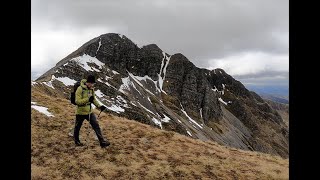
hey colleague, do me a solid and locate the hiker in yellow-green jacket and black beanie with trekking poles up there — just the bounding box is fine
[74,75,110,148]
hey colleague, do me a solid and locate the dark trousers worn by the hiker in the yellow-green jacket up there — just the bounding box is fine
[74,113,105,143]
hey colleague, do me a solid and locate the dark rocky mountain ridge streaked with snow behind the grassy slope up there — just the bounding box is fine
[32,33,289,158]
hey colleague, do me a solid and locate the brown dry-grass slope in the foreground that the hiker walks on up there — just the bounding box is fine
[31,85,289,180]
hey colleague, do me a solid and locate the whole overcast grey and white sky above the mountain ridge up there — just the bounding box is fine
[31,0,289,86]
